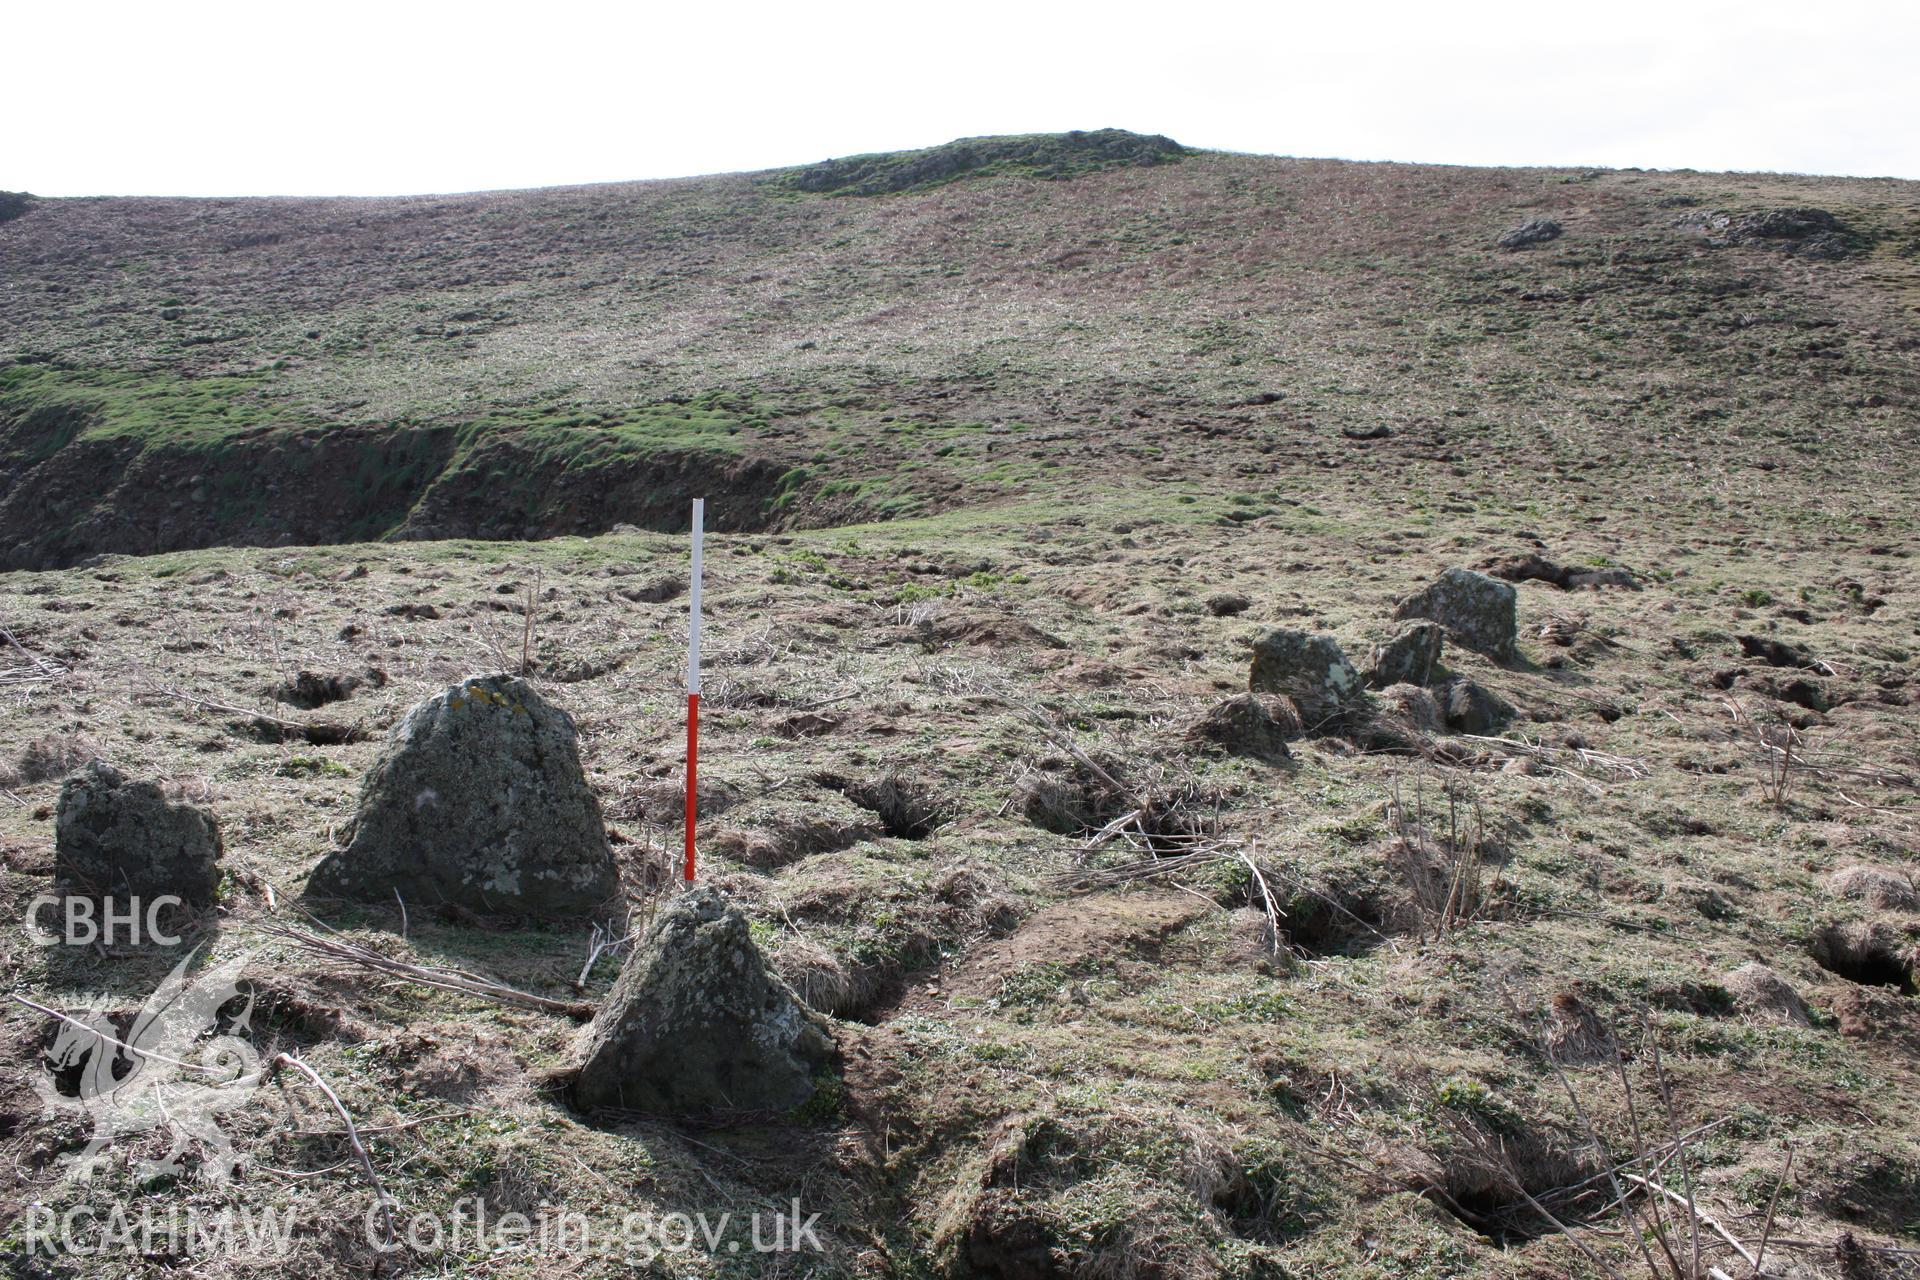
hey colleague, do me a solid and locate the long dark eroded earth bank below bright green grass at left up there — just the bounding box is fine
[0,416,851,568]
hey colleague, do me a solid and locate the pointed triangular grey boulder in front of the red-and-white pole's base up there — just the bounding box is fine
[572,887,837,1115]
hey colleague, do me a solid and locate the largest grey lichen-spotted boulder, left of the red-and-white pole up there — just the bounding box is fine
[311,676,620,921]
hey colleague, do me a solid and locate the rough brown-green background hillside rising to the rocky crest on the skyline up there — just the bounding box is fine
[0,134,1920,564]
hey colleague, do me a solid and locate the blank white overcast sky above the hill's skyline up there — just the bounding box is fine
[15,0,1920,196]
